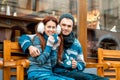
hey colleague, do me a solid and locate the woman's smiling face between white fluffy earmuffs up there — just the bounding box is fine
[45,21,57,36]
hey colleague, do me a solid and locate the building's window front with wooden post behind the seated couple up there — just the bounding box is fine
[0,0,120,79]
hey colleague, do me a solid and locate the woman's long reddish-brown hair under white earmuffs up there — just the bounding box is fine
[36,16,63,62]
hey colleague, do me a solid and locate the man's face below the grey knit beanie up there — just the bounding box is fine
[60,18,73,35]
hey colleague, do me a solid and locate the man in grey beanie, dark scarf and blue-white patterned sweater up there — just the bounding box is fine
[18,14,108,80]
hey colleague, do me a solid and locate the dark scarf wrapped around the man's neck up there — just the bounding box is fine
[63,32,75,49]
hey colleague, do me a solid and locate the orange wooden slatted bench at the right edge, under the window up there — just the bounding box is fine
[98,48,120,80]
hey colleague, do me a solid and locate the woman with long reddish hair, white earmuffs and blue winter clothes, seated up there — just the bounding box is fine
[19,16,73,80]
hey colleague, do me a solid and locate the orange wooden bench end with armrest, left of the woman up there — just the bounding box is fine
[1,40,30,80]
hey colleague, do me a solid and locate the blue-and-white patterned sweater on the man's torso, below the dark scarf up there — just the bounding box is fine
[54,38,85,73]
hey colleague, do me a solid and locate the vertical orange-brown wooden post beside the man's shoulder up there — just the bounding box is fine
[77,0,87,61]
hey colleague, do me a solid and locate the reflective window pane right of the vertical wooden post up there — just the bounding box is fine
[87,0,120,57]
